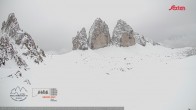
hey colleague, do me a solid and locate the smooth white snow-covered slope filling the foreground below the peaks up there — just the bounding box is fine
[0,43,196,110]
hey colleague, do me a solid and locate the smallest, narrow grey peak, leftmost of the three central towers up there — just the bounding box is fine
[72,28,88,50]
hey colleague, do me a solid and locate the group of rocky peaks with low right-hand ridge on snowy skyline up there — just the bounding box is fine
[72,18,158,50]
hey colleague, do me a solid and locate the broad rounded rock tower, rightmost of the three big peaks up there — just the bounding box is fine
[112,20,135,47]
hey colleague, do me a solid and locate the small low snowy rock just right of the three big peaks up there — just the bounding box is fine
[134,33,147,46]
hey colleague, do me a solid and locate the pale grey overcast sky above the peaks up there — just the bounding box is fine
[0,0,196,51]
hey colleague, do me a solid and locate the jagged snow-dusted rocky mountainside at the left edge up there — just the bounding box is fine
[0,13,46,85]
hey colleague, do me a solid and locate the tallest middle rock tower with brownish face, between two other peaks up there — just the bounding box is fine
[88,18,110,49]
